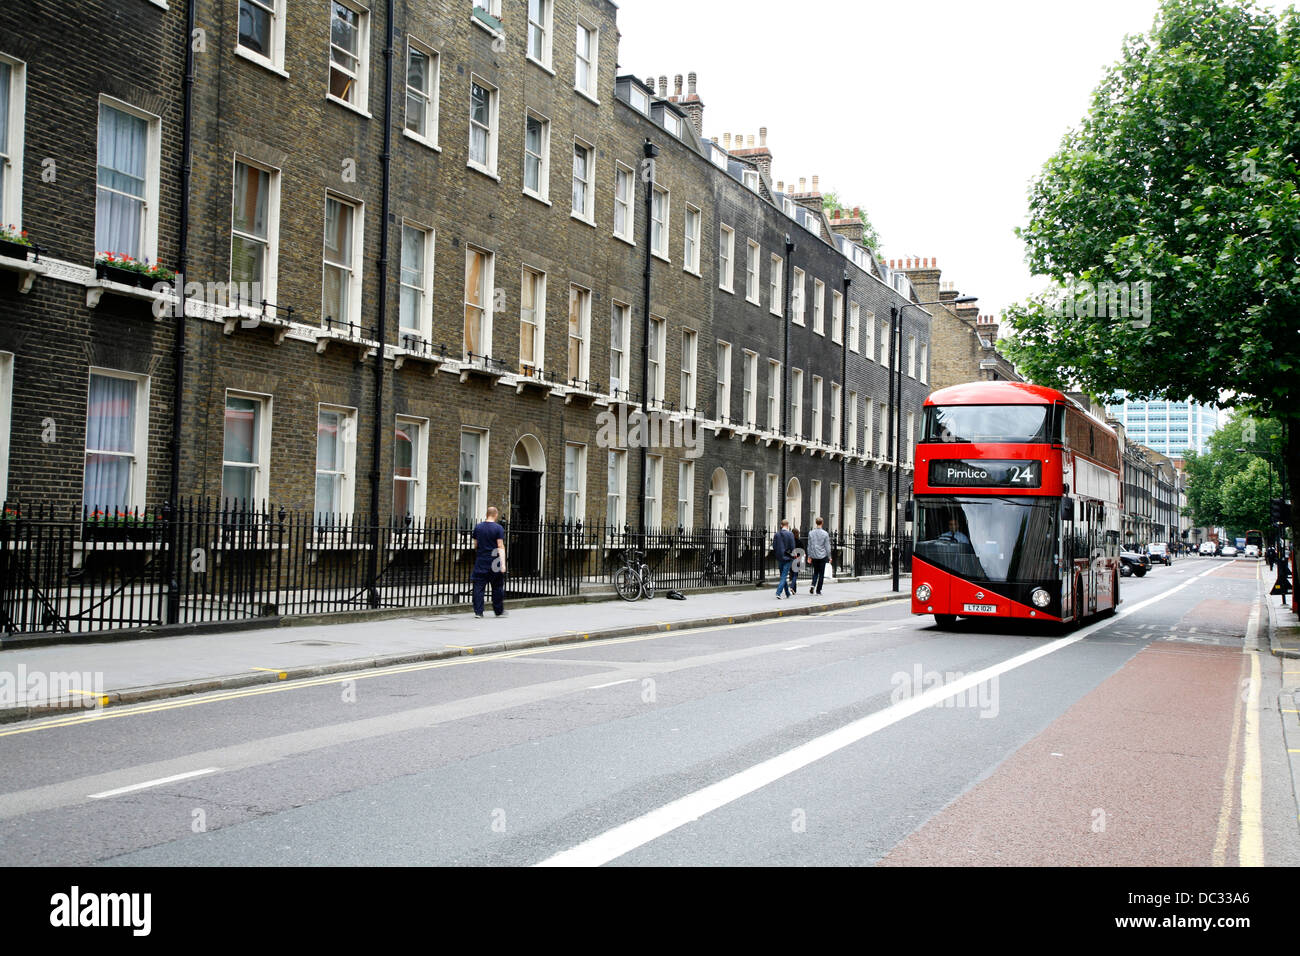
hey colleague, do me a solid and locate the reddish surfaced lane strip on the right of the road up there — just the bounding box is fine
[880,634,1249,866]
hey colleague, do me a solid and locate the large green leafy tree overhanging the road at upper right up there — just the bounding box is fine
[1005,0,1300,582]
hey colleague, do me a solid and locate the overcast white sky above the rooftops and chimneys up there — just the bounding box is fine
[618,0,1286,323]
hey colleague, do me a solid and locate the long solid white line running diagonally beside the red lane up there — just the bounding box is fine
[534,568,1214,866]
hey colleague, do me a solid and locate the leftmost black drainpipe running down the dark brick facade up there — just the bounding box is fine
[166,0,198,624]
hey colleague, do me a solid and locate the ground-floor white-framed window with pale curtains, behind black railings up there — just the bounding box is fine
[83,375,138,512]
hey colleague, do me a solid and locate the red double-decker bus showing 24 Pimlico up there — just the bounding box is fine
[911,382,1122,627]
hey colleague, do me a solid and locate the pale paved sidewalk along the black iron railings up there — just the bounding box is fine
[0,576,910,722]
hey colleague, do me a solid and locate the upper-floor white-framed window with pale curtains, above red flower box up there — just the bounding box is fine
[95,104,150,259]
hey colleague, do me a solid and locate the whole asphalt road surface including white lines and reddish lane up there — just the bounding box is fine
[0,558,1300,866]
